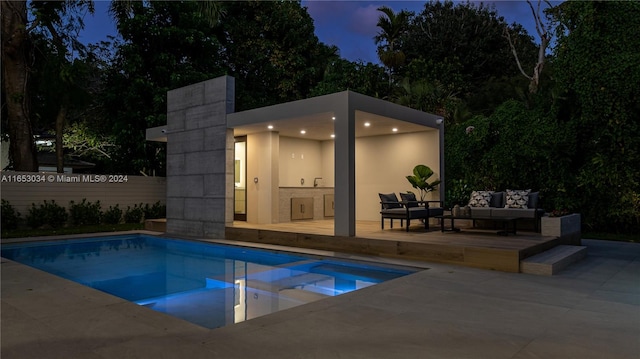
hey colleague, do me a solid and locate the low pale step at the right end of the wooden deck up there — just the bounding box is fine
[520,245,587,275]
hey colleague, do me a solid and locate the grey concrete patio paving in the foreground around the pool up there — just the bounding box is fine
[0,240,640,359]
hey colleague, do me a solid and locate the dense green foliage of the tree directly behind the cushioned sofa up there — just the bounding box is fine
[445,100,578,210]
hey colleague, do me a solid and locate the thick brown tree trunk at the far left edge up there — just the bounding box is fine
[0,0,38,172]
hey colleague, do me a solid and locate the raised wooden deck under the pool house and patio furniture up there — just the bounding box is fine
[226,220,562,272]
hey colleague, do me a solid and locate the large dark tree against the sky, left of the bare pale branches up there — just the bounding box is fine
[401,1,537,114]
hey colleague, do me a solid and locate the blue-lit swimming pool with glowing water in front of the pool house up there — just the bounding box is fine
[1,234,418,328]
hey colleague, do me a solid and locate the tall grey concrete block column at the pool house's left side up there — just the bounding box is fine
[167,76,235,238]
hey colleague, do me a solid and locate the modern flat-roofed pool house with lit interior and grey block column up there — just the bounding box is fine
[147,76,444,238]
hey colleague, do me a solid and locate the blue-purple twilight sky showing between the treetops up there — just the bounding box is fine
[81,0,537,63]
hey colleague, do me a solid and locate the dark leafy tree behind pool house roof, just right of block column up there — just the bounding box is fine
[219,1,337,111]
